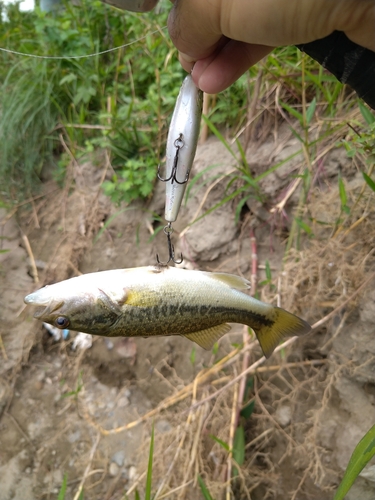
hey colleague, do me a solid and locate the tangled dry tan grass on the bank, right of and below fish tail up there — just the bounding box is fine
[78,174,375,500]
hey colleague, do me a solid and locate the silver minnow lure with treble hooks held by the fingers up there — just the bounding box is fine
[165,75,203,222]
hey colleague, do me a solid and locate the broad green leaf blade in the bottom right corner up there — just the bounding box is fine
[333,425,375,500]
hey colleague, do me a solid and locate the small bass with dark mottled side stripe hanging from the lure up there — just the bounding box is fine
[24,266,311,357]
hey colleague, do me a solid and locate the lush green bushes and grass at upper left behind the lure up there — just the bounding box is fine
[0,0,250,202]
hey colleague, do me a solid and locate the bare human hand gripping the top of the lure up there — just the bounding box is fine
[168,0,375,94]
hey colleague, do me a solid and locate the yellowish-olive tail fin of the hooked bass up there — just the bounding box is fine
[251,307,311,358]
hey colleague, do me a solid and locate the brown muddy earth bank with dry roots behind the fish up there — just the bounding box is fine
[0,127,375,500]
